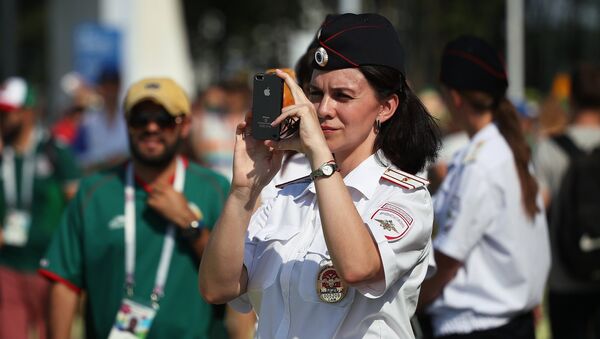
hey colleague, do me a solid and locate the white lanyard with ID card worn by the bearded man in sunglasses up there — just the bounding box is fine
[108,158,185,339]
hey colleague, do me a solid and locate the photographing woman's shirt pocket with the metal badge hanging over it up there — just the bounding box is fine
[298,237,355,308]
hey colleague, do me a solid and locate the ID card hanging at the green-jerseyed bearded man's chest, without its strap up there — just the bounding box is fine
[108,298,156,339]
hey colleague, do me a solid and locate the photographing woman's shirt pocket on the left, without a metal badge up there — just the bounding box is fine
[248,226,300,290]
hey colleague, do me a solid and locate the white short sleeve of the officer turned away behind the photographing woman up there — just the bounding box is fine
[434,166,503,262]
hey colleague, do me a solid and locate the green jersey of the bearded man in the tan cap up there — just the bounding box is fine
[40,163,229,339]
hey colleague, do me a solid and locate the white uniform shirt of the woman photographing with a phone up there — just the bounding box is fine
[231,156,433,339]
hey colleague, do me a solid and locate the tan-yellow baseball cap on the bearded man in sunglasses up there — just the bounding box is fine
[124,78,190,117]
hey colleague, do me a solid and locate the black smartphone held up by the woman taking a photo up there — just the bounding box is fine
[252,73,283,140]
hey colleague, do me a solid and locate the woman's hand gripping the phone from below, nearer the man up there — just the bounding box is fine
[231,112,283,196]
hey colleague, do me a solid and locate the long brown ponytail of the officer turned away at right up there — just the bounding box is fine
[460,91,540,218]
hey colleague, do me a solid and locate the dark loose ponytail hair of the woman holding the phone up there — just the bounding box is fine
[359,65,441,174]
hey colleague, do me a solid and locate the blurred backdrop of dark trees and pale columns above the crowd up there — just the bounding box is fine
[0,0,600,123]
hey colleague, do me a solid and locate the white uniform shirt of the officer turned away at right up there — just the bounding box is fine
[428,124,550,335]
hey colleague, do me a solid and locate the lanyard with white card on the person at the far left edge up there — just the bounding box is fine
[2,131,38,247]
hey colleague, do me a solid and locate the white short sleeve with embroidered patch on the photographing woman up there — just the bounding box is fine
[355,189,433,298]
